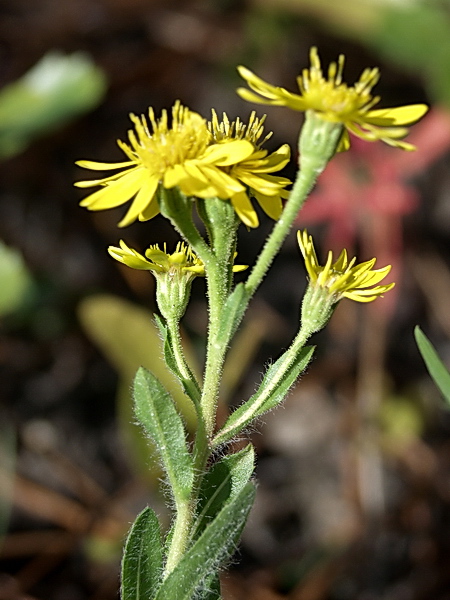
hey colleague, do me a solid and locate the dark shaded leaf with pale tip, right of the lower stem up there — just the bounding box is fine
[195,444,255,537]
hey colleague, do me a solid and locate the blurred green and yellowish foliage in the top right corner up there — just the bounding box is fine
[259,0,450,106]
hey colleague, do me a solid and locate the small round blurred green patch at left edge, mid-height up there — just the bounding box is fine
[0,242,32,316]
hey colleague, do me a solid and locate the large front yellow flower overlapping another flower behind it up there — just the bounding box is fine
[75,101,253,227]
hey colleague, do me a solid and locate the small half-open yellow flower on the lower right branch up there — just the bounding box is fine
[297,229,395,303]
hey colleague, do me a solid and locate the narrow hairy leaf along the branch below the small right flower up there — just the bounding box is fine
[212,346,315,447]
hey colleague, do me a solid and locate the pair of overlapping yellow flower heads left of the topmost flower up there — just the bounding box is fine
[75,101,290,227]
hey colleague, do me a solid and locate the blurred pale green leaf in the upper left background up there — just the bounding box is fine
[0,51,106,158]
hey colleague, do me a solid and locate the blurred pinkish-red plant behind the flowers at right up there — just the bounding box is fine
[297,109,450,312]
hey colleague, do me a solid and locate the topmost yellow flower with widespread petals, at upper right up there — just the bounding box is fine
[238,48,428,150]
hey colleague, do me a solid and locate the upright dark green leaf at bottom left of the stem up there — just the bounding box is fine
[121,507,163,600]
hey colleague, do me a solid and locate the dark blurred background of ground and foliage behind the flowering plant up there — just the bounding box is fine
[0,0,450,600]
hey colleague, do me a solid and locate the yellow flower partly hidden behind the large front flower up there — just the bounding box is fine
[208,110,291,227]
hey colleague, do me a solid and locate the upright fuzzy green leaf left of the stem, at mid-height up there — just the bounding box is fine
[134,367,194,498]
